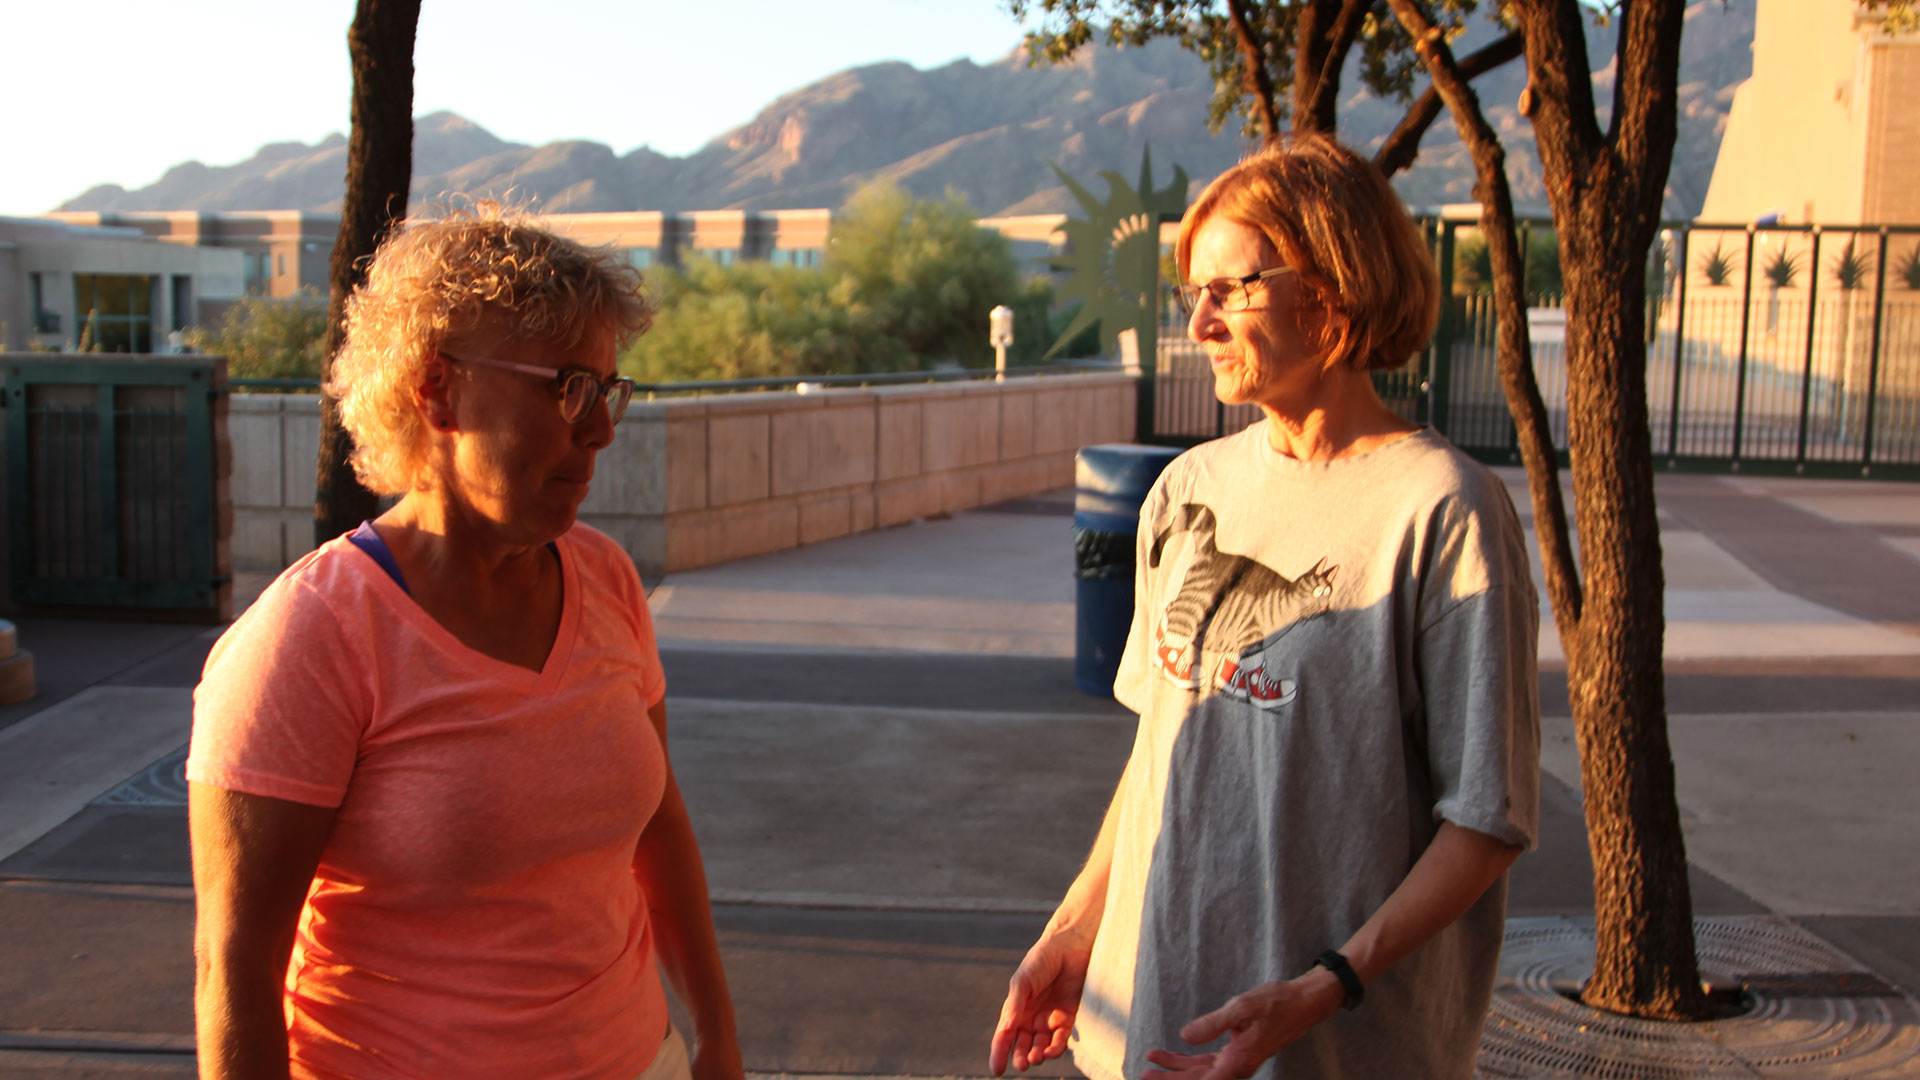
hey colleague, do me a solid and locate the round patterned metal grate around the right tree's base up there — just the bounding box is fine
[1476,917,1920,1080]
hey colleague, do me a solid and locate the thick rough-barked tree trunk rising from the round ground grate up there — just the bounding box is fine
[1515,0,1707,1020]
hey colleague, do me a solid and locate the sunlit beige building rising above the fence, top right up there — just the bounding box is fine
[1699,0,1920,225]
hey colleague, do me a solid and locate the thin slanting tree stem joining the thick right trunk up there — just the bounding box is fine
[1388,0,1584,634]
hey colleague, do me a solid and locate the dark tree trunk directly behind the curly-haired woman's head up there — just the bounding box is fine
[313,0,420,546]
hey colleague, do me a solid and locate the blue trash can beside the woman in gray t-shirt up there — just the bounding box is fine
[1073,442,1181,698]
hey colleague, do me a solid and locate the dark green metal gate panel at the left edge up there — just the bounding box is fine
[0,356,227,617]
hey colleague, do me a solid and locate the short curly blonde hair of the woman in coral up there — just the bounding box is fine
[323,202,653,496]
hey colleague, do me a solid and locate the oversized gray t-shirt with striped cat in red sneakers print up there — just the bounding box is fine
[1071,425,1540,1080]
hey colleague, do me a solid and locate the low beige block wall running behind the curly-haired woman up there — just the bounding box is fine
[240,375,1137,577]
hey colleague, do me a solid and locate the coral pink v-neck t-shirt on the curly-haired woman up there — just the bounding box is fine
[186,525,666,1080]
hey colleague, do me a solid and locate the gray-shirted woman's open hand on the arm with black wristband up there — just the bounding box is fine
[1140,969,1346,1080]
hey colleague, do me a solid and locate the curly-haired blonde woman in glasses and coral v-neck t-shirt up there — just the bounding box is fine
[186,206,741,1080]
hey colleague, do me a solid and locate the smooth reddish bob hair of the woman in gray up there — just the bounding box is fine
[1175,133,1440,371]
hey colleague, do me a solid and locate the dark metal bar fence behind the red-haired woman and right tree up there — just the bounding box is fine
[1142,221,1920,480]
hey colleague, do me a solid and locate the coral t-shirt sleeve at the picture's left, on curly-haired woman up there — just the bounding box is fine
[186,577,372,807]
